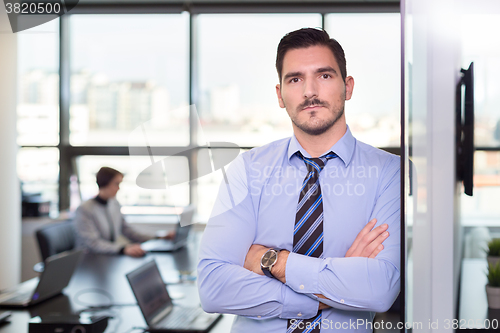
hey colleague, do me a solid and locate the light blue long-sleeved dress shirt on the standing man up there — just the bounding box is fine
[198,128,400,333]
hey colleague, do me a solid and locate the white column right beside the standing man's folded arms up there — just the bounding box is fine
[406,0,461,333]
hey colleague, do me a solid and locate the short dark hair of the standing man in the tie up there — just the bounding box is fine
[276,28,347,83]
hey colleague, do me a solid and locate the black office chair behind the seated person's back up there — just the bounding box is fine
[33,220,76,272]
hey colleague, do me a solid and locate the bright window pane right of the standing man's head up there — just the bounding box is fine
[325,14,401,147]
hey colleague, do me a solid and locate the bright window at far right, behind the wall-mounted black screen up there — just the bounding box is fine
[460,14,500,226]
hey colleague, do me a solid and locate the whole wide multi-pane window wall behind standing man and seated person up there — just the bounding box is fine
[18,5,400,220]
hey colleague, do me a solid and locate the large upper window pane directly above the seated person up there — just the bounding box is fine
[70,14,189,146]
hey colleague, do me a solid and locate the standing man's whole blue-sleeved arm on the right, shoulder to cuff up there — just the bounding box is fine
[285,160,400,312]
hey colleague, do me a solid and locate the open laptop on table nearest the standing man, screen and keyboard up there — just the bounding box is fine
[127,260,222,333]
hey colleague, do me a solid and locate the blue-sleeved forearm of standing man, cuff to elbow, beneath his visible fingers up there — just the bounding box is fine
[286,253,399,312]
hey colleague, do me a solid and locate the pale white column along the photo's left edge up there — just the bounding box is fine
[0,7,21,289]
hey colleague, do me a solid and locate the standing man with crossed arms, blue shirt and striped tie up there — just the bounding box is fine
[198,28,400,333]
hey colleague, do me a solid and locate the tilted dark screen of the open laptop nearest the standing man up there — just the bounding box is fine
[127,260,172,323]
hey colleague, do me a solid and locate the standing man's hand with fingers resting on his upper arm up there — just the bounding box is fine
[345,219,389,259]
